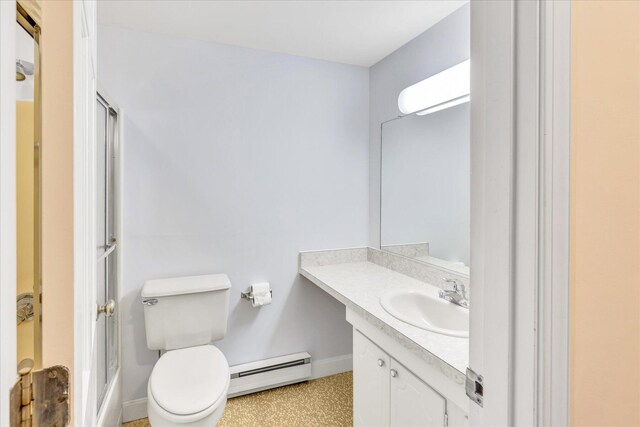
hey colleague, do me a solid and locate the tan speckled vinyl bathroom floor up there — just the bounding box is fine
[124,372,353,427]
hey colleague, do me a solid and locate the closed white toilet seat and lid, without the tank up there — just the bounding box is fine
[148,345,230,424]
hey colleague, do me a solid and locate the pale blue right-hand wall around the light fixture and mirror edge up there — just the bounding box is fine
[369,4,470,247]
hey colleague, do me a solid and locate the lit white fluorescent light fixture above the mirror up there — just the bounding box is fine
[398,59,471,114]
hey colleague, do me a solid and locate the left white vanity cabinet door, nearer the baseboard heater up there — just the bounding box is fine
[353,329,390,427]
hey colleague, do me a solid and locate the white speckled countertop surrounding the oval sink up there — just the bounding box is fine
[300,261,469,379]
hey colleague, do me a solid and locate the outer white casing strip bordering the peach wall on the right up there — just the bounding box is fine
[537,0,571,426]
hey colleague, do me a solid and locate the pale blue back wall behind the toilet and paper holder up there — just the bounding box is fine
[98,27,369,401]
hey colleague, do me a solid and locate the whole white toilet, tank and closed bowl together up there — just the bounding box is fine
[142,274,231,427]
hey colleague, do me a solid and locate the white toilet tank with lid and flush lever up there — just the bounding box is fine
[142,274,231,350]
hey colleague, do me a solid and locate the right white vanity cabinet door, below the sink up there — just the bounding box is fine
[390,359,446,427]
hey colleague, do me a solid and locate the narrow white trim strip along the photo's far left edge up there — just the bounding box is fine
[0,0,17,426]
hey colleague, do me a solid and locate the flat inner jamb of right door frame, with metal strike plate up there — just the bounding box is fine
[469,0,515,426]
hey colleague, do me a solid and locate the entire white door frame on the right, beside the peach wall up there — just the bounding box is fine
[469,0,571,426]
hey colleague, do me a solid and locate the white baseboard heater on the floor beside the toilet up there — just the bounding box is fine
[228,352,311,397]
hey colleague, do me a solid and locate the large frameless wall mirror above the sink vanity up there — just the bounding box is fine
[380,103,470,275]
